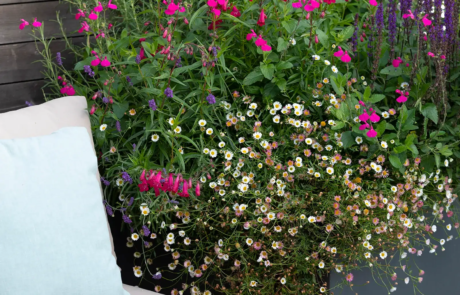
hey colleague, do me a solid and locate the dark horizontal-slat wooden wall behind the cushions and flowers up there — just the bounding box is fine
[0,0,83,112]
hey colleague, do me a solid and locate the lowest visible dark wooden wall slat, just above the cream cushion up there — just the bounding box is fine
[0,80,45,113]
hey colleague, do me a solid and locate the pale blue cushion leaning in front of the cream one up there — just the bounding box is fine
[0,127,129,295]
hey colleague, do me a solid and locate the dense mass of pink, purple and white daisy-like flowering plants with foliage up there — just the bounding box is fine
[20,0,460,295]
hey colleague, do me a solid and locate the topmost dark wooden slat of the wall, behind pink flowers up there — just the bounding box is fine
[0,1,80,44]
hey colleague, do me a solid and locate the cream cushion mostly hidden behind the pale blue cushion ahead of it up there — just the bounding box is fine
[0,96,161,295]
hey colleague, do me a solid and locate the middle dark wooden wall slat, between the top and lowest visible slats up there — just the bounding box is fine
[0,37,86,84]
